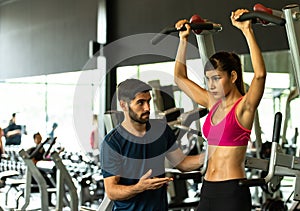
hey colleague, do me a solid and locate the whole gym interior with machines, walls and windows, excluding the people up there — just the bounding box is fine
[0,0,300,211]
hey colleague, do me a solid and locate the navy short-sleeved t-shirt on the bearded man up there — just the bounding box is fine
[100,120,178,211]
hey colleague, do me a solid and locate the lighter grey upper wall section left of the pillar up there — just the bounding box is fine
[0,0,97,79]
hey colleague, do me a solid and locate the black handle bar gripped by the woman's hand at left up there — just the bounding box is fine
[151,22,222,45]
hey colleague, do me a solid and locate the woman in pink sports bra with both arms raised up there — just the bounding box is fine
[174,9,266,211]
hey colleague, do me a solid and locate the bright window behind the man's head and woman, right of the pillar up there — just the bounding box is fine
[117,59,300,146]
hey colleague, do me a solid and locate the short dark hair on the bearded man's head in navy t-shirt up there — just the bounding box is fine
[118,79,152,102]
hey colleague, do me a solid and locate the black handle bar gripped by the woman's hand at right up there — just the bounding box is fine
[238,11,286,26]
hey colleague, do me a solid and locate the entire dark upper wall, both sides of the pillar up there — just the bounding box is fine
[0,0,299,79]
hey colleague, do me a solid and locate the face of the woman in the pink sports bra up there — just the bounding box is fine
[205,70,234,99]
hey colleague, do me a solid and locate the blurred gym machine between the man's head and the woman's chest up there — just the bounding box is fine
[148,80,208,155]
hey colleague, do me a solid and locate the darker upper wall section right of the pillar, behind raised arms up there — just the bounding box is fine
[108,0,299,65]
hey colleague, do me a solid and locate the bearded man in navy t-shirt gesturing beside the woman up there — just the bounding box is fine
[100,79,204,211]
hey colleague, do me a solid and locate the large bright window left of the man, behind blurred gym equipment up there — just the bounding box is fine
[0,72,104,151]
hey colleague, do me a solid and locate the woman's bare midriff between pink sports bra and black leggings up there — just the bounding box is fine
[204,146,247,181]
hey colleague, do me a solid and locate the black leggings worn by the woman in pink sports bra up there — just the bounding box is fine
[197,179,251,211]
